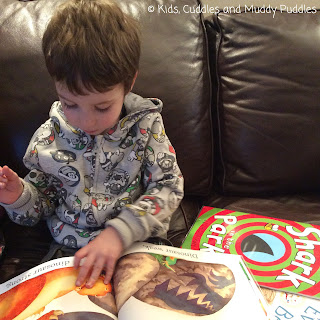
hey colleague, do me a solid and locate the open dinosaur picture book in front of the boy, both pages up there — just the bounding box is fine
[0,243,268,320]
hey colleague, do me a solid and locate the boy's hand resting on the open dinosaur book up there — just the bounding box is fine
[74,227,123,288]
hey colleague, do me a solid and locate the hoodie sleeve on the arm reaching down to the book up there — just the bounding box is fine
[106,113,183,247]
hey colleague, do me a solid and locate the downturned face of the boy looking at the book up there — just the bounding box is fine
[55,82,125,136]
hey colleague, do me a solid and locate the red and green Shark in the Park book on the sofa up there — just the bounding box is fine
[182,207,320,299]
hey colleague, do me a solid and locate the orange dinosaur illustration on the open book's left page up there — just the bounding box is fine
[0,267,112,320]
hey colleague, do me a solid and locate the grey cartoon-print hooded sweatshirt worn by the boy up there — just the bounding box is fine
[4,93,183,248]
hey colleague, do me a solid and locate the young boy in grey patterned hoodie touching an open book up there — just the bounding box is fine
[0,0,183,288]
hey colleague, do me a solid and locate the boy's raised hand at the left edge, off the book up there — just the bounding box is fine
[0,166,23,204]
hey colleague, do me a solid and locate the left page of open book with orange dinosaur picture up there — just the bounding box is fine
[0,257,117,320]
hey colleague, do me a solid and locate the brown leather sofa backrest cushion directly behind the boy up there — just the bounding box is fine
[0,0,213,195]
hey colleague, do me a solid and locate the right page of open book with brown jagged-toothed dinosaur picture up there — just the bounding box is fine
[114,243,268,320]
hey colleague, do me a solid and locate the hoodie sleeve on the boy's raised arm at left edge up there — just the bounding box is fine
[1,127,57,226]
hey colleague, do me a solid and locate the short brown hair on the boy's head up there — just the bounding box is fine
[42,0,140,95]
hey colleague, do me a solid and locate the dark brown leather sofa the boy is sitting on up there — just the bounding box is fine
[0,0,320,282]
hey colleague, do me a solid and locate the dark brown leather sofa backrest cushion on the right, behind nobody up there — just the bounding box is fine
[207,10,320,196]
